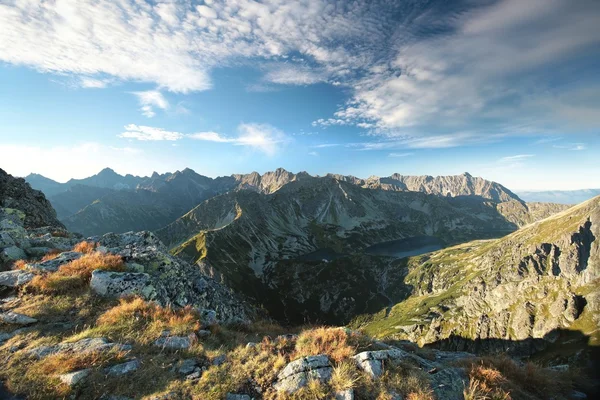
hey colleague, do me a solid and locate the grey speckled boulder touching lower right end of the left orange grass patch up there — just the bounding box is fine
[90,270,155,299]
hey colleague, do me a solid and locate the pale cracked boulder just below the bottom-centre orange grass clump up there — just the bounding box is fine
[273,354,333,393]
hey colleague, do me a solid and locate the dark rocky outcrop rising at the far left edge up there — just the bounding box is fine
[0,169,64,228]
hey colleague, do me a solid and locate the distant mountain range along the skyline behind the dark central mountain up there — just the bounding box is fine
[29,168,560,239]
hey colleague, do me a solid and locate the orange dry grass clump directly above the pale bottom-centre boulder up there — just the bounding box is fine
[294,327,359,362]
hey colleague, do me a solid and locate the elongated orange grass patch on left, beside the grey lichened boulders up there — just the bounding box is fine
[26,252,125,294]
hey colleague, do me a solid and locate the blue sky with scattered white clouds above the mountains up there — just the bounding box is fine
[0,0,600,190]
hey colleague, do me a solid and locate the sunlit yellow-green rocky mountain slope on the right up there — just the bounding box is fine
[357,197,600,352]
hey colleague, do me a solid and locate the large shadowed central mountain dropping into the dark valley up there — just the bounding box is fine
[156,176,565,323]
